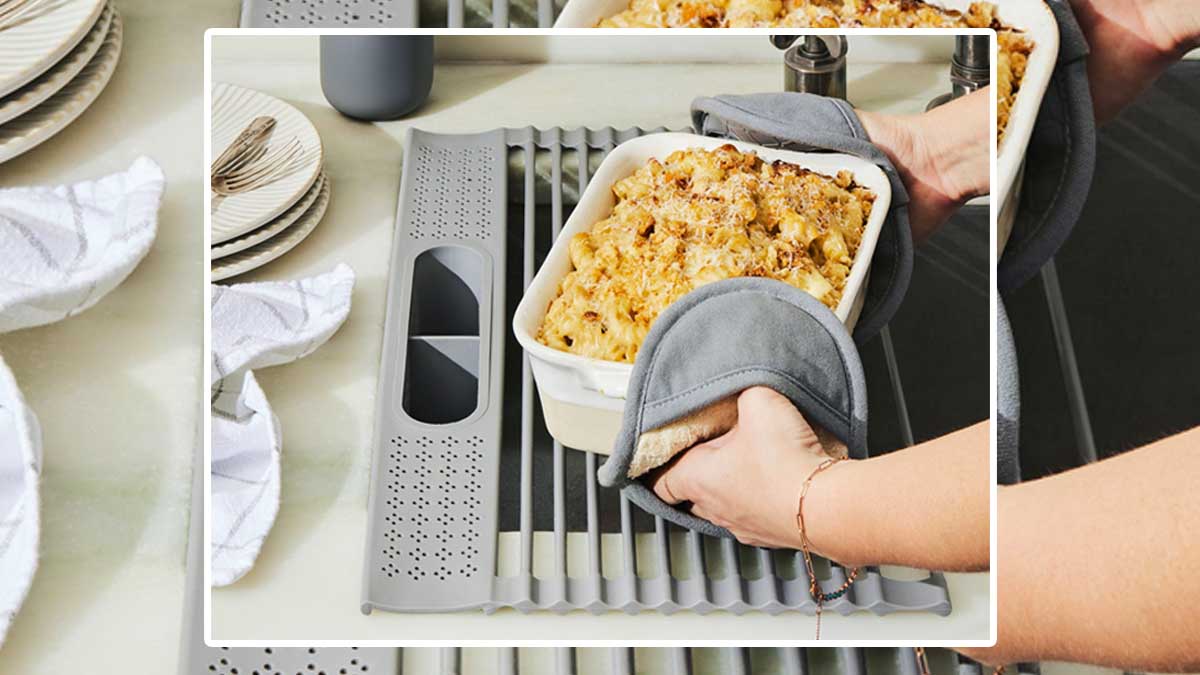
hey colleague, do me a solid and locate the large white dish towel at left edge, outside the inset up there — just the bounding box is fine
[0,157,166,645]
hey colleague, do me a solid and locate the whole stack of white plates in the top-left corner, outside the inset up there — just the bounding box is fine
[0,0,121,163]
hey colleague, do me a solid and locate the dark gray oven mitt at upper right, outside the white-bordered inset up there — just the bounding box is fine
[996,0,1096,293]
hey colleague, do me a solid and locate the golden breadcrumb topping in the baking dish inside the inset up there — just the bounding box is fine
[538,144,875,363]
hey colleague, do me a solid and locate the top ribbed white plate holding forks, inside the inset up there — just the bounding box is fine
[212,83,323,244]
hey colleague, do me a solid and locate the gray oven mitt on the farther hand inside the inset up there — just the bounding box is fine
[691,92,912,345]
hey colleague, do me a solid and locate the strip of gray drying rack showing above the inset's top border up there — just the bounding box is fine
[240,0,562,28]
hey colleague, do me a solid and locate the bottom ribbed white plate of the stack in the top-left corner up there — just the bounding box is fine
[0,12,124,162]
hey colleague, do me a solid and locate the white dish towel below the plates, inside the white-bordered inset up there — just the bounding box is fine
[209,264,354,586]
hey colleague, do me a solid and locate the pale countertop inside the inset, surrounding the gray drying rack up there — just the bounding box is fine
[212,37,989,640]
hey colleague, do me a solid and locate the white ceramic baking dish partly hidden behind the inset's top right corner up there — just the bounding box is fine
[554,0,1058,250]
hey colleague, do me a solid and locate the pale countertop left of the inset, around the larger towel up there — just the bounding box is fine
[0,0,236,675]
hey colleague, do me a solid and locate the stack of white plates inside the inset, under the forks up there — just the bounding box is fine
[211,83,329,281]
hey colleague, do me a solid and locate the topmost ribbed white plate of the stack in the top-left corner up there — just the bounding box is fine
[0,0,108,96]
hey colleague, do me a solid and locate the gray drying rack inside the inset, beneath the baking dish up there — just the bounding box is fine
[361,127,950,615]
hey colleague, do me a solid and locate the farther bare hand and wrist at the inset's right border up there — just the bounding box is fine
[857,86,991,244]
